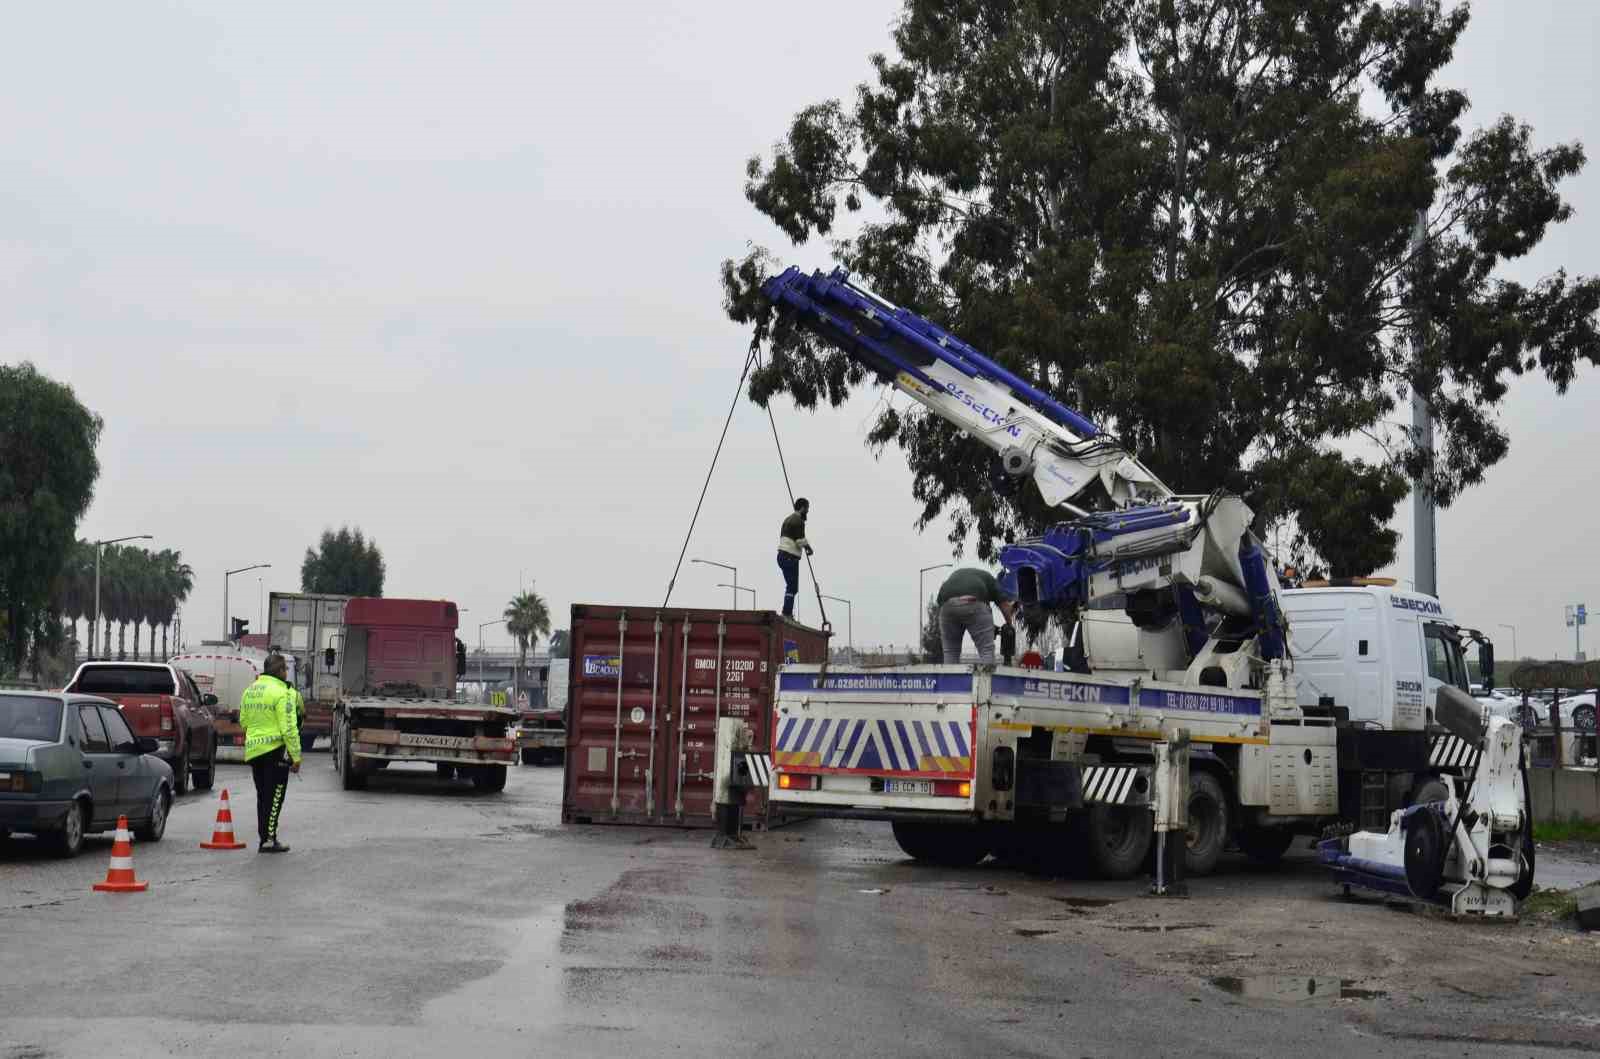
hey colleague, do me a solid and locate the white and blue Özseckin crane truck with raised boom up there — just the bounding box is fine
[763,269,1533,894]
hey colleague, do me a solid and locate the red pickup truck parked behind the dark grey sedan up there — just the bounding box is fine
[66,662,216,793]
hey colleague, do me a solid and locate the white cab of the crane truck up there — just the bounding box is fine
[1280,582,1469,731]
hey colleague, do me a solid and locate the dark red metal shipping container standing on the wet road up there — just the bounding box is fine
[562,605,827,827]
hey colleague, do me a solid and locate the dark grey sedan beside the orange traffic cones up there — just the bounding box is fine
[0,691,173,857]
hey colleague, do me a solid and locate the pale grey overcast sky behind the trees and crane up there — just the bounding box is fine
[12,0,1600,656]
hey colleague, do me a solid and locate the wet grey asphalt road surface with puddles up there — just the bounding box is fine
[0,753,1600,1059]
